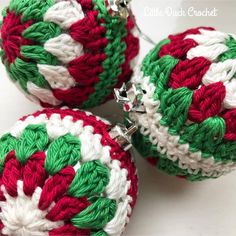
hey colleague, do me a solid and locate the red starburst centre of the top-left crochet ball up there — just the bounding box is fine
[1,10,33,64]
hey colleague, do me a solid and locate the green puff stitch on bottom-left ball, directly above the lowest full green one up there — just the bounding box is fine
[68,160,110,198]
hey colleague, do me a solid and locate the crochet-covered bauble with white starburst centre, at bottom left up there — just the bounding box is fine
[0,109,137,236]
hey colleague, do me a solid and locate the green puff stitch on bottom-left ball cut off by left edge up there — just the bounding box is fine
[0,133,17,173]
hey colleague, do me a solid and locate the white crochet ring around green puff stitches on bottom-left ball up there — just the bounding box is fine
[7,109,132,235]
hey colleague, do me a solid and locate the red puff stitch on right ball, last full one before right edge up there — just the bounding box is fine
[188,82,226,123]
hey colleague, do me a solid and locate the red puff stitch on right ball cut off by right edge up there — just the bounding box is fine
[221,109,236,141]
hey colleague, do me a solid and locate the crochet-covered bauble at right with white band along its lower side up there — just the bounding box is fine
[130,27,236,181]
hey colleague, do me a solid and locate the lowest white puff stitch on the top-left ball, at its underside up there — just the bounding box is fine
[27,81,62,106]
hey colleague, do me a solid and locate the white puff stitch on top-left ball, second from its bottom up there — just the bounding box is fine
[37,64,76,90]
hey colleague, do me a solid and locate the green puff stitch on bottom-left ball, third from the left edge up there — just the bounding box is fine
[44,134,81,175]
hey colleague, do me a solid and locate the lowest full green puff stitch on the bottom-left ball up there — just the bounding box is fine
[71,197,117,230]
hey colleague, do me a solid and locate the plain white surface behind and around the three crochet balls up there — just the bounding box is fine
[0,0,236,236]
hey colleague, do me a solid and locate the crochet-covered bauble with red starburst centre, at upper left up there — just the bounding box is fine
[0,0,139,108]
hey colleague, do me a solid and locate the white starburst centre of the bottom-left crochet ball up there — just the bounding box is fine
[0,180,64,236]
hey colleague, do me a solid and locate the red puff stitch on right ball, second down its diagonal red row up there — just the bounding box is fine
[169,57,211,90]
